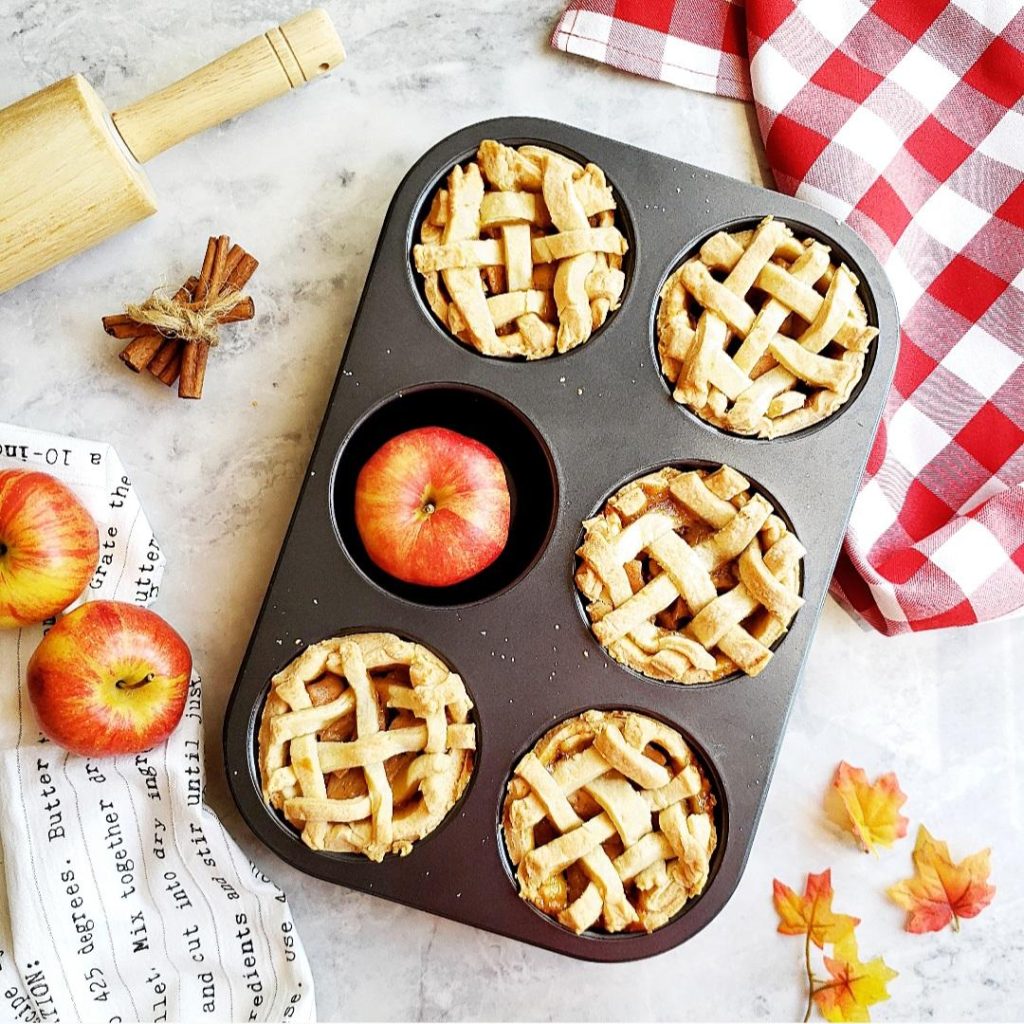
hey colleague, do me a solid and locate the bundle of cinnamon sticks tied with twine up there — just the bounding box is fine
[103,234,259,398]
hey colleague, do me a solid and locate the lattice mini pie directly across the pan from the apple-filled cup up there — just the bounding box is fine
[575,466,804,683]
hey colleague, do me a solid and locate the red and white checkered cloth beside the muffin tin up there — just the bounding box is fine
[552,0,1024,634]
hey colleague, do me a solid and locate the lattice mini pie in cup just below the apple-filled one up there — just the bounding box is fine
[259,633,476,861]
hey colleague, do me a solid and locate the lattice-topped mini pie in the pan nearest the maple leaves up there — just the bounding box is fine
[503,711,717,934]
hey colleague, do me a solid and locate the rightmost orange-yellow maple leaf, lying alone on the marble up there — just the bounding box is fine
[888,825,995,933]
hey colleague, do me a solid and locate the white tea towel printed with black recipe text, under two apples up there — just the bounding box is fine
[0,424,315,1022]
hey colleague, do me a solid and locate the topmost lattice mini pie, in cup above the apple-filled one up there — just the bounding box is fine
[413,139,627,359]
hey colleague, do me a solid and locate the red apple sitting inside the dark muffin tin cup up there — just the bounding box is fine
[355,427,511,587]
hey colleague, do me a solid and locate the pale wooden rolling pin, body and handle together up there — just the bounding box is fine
[0,10,345,292]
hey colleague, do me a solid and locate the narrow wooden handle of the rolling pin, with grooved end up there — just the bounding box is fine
[112,9,345,163]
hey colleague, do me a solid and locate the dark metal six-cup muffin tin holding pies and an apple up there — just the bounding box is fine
[224,118,898,962]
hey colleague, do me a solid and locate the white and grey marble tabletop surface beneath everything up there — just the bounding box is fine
[0,0,1024,1020]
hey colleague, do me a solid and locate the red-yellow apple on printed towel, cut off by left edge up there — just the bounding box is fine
[0,469,99,629]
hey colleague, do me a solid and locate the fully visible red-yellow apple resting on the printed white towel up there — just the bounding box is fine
[27,601,191,757]
